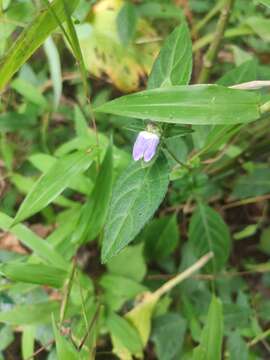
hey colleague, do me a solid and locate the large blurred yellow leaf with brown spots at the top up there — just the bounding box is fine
[76,0,160,92]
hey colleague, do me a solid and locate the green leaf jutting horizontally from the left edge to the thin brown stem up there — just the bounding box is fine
[0,263,68,288]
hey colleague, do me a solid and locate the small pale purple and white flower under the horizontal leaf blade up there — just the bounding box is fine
[132,131,159,162]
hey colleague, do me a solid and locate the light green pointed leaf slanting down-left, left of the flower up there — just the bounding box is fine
[14,151,93,224]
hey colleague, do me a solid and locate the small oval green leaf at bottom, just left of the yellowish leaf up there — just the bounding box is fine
[106,312,142,354]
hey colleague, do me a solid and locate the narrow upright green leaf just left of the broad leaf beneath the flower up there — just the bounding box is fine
[72,144,113,244]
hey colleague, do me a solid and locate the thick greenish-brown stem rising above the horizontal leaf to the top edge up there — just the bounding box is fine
[198,0,234,83]
